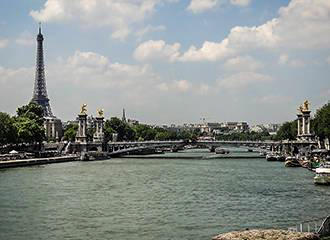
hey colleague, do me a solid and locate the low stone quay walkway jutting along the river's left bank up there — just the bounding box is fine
[0,154,80,169]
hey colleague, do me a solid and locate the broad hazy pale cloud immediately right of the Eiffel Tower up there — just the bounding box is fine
[56,51,157,88]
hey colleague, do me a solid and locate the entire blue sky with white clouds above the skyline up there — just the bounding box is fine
[0,0,330,123]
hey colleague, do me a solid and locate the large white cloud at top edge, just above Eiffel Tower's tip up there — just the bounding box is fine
[30,0,176,40]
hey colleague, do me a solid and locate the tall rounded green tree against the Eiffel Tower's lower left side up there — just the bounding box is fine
[14,103,45,143]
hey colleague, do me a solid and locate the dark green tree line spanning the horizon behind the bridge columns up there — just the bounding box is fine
[0,103,330,145]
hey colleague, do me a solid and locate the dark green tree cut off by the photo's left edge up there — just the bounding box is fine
[0,112,17,144]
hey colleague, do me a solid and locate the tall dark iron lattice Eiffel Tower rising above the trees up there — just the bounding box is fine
[31,23,54,117]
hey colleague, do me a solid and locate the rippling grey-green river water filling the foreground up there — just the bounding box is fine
[0,149,330,240]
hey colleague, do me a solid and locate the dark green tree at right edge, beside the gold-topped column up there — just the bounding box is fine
[312,103,330,140]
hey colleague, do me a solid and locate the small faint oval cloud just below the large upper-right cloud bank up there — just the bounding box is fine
[224,56,262,72]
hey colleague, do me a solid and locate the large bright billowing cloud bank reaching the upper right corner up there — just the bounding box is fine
[181,0,330,62]
